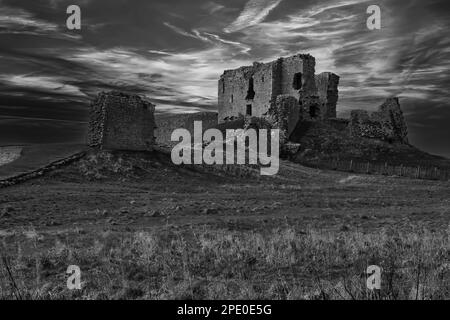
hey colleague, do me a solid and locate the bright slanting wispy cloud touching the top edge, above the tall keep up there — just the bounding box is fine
[224,0,282,33]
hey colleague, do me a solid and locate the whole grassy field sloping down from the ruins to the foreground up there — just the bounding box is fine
[0,152,450,299]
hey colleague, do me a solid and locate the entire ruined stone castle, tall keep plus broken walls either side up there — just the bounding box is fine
[88,54,408,150]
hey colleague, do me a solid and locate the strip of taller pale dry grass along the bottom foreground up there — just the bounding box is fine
[0,227,450,300]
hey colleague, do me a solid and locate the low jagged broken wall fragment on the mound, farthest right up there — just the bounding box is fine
[348,98,408,143]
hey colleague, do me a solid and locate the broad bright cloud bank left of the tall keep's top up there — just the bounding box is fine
[70,45,253,105]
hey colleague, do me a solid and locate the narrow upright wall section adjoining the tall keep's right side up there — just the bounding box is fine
[315,72,339,119]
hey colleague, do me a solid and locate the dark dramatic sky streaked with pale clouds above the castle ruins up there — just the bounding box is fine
[0,0,450,157]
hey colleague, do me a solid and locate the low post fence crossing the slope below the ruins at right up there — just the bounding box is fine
[301,160,450,181]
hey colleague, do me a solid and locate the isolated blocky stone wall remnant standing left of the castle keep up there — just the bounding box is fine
[88,91,155,150]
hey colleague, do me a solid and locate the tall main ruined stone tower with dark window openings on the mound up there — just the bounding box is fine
[218,54,321,123]
